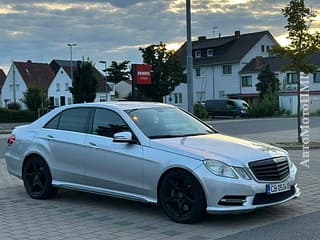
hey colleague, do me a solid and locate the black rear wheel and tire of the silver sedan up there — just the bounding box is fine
[22,156,57,199]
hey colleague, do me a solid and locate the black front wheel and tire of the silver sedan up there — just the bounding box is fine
[159,170,206,223]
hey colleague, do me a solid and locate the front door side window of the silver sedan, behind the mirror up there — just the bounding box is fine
[92,109,130,138]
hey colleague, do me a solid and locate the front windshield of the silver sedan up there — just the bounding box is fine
[127,107,214,139]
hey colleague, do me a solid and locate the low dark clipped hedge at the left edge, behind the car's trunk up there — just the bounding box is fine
[0,108,37,123]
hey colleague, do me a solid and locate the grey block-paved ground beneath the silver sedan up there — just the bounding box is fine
[0,150,320,240]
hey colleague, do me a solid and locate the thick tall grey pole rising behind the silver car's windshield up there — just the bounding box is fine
[186,0,193,112]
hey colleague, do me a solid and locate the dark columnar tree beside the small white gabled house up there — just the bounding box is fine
[69,59,99,103]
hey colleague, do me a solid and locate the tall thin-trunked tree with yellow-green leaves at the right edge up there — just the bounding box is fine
[271,0,320,143]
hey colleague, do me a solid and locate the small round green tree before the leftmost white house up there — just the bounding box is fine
[22,87,49,112]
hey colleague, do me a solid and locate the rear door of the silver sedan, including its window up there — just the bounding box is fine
[38,108,90,184]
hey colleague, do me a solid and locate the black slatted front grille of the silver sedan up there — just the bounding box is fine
[249,157,289,181]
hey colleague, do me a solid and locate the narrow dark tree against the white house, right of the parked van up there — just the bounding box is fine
[256,64,279,110]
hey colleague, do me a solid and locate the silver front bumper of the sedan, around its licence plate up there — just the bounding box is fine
[192,165,301,214]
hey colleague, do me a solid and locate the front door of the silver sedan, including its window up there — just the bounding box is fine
[85,108,143,197]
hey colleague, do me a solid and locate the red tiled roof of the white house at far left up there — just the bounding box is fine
[14,61,54,91]
